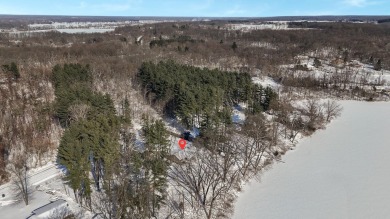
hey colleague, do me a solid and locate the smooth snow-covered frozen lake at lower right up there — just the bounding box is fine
[233,101,390,219]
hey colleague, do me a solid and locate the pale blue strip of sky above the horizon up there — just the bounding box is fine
[0,0,390,17]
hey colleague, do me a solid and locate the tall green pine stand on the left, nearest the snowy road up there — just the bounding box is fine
[53,64,121,207]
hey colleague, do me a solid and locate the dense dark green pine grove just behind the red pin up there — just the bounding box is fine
[138,61,277,129]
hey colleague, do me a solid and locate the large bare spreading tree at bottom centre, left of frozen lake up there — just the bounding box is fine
[169,151,237,219]
